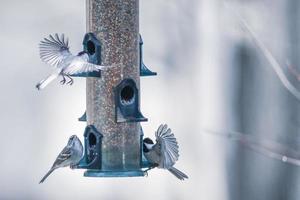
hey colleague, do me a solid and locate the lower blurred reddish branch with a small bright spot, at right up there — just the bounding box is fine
[203,129,300,166]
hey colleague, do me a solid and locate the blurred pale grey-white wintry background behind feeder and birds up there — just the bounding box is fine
[0,0,300,200]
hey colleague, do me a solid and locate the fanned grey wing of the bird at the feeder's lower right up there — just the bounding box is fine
[154,124,179,169]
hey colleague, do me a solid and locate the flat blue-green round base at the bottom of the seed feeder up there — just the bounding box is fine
[84,170,145,177]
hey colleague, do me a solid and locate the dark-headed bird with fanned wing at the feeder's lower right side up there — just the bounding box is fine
[143,124,188,180]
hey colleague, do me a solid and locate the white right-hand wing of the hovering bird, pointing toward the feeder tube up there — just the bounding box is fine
[63,59,105,75]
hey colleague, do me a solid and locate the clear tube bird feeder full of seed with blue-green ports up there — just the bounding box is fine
[77,0,156,177]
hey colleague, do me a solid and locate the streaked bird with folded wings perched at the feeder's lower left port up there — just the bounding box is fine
[40,135,83,183]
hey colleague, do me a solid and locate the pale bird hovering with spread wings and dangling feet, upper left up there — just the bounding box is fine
[36,34,104,90]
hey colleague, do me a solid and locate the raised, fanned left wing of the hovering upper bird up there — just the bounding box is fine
[40,33,72,67]
